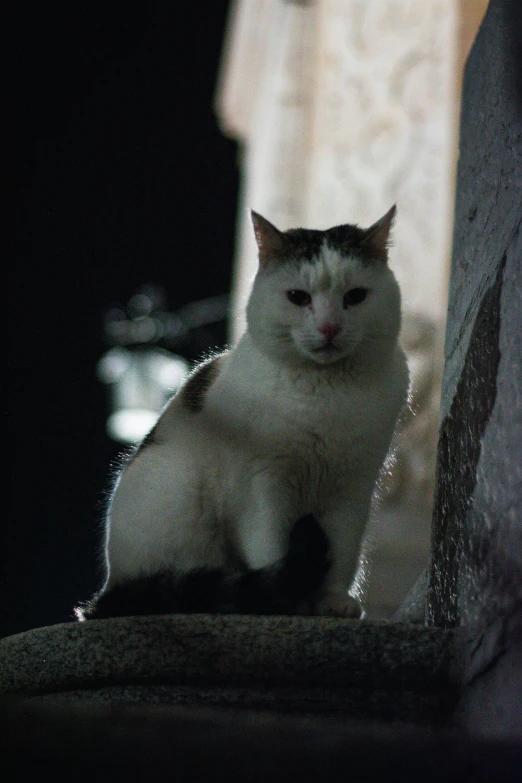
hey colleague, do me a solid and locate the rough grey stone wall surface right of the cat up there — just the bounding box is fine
[427,0,522,732]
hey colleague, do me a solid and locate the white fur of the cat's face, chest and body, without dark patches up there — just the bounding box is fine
[101,236,408,615]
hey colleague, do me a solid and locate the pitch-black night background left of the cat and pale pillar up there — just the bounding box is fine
[2,0,238,635]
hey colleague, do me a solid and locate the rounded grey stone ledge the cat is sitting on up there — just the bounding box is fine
[0,614,459,725]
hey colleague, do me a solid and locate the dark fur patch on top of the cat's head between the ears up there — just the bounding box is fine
[284,224,385,263]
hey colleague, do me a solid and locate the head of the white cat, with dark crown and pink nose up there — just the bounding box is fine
[247,206,400,365]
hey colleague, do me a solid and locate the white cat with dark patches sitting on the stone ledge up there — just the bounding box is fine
[75,206,409,620]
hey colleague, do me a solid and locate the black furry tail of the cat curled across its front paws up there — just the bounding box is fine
[74,514,330,620]
